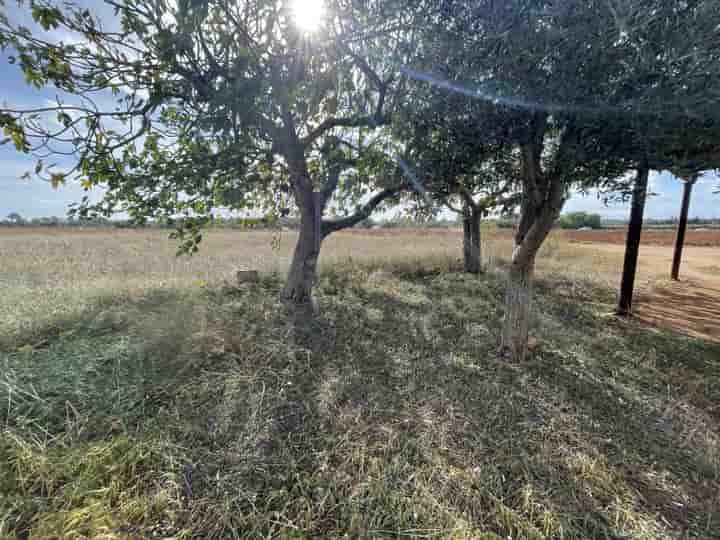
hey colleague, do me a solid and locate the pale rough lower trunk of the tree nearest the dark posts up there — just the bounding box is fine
[500,256,535,362]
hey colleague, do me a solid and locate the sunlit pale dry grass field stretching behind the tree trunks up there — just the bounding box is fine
[0,229,618,347]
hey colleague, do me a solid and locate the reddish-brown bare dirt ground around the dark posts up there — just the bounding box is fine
[592,244,720,342]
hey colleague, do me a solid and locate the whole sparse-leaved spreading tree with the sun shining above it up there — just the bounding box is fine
[0,0,422,304]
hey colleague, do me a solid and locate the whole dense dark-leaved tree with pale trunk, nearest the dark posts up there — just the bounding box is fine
[410,0,720,360]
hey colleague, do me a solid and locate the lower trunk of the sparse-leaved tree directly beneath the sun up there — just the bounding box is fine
[282,193,322,309]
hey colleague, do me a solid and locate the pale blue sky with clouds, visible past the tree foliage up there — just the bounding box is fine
[0,0,720,219]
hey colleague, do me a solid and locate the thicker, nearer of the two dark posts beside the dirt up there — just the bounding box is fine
[618,167,650,317]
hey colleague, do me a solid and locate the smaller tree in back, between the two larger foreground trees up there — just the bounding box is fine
[393,30,518,274]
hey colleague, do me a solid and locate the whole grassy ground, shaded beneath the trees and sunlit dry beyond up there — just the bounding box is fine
[0,231,720,540]
